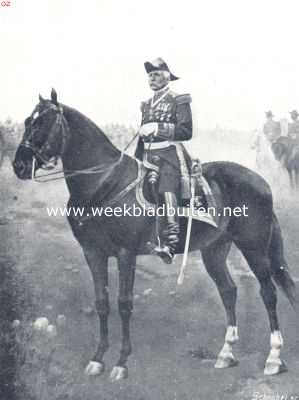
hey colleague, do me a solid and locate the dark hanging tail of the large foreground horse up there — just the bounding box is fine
[269,213,299,313]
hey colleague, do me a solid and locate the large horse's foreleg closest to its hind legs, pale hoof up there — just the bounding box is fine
[110,249,136,381]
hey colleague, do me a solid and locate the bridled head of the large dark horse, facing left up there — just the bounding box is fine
[13,89,70,179]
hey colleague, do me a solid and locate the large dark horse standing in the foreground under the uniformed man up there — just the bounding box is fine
[13,90,298,380]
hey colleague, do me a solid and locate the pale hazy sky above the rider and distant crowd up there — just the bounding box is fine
[0,0,299,129]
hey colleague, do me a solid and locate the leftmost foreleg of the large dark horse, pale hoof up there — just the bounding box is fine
[83,248,109,375]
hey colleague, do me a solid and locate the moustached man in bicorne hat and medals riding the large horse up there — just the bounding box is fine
[135,58,192,263]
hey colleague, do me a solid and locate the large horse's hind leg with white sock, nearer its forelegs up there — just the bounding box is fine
[202,242,239,368]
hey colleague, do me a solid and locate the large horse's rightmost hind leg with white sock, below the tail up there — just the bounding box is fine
[241,249,286,375]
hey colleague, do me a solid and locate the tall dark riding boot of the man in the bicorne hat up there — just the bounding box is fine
[155,192,180,264]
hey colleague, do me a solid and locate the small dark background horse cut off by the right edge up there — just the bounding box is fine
[271,136,299,189]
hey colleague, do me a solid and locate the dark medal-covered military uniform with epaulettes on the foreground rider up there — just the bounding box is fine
[135,87,192,194]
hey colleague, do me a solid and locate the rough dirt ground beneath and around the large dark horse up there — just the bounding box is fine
[0,157,299,400]
